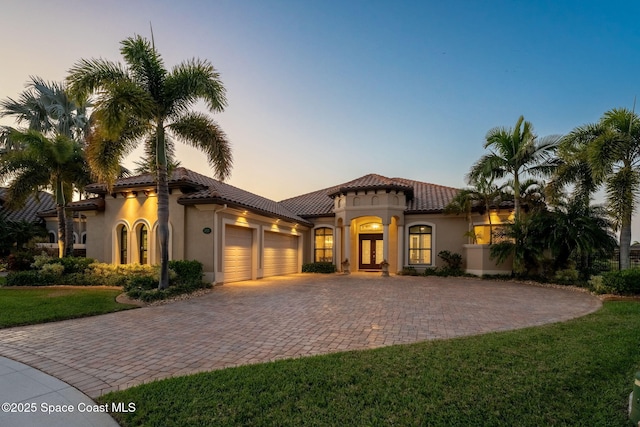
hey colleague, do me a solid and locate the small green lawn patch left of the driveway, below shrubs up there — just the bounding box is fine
[0,286,134,328]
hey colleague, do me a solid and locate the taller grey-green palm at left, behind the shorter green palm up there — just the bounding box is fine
[0,77,90,256]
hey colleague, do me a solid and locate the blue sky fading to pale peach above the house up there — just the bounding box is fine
[0,0,640,239]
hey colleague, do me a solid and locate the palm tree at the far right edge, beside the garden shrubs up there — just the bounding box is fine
[563,108,640,270]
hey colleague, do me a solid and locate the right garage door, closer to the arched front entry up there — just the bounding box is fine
[263,232,298,277]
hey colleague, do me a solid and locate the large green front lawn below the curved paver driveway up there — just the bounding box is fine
[99,302,640,427]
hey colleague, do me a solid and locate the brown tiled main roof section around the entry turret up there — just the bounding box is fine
[280,174,458,217]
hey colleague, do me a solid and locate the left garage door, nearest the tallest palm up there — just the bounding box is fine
[224,226,253,282]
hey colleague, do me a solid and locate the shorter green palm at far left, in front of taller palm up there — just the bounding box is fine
[0,130,89,257]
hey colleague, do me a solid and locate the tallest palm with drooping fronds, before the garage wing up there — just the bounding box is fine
[67,36,232,289]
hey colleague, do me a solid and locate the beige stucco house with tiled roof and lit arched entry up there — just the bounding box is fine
[57,167,511,283]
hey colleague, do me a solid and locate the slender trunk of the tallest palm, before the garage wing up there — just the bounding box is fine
[156,122,169,289]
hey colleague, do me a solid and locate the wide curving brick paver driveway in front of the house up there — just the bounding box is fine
[0,273,601,397]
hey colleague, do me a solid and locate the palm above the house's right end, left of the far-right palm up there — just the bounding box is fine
[467,116,560,219]
